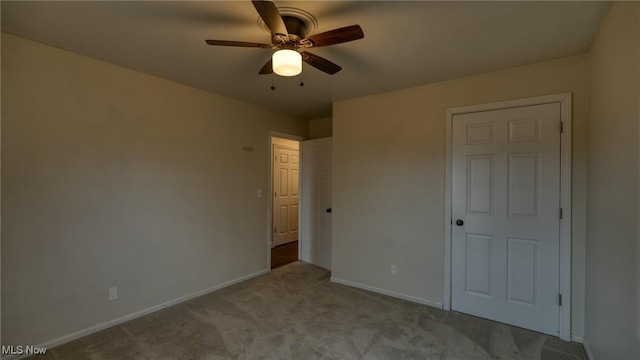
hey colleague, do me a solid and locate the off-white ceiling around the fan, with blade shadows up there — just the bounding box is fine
[0,1,609,119]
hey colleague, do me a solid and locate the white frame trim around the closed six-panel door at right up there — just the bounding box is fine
[443,93,571,341]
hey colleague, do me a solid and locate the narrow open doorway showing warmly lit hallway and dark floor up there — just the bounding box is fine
[270,136,300,269]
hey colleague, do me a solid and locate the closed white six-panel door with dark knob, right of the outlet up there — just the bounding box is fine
[451,103,561,336]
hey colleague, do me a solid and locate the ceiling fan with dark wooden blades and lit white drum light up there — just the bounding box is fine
[206,0,364,76]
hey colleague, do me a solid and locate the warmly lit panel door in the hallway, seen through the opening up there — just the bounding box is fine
[273,144,300,246]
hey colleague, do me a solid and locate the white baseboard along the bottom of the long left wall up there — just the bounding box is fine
[1,269,269,360]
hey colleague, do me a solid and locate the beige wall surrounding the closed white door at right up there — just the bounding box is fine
[332,56,587,337]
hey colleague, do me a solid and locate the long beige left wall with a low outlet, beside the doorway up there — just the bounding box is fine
[2,34,307,345]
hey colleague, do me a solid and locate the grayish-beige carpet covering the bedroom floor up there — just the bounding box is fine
[34,261,586,360]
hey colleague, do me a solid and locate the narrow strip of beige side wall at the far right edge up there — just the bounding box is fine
[585,2,640,360]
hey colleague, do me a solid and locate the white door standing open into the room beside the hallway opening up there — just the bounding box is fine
[300,138,332,270]
